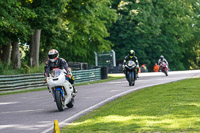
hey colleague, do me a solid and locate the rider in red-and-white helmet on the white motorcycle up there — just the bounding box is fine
[44,49,77,93]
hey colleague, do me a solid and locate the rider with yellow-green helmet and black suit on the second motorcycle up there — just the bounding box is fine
[122,50,139,79]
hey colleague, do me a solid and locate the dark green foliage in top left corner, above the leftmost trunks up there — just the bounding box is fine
[0,0,35,45]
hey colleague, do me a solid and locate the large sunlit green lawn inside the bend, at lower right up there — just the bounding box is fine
[61,78,200,133]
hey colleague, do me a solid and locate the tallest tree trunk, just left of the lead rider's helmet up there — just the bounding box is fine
[30,29,41,67]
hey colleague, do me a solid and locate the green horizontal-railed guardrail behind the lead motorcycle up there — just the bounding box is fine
[0,68,101,91]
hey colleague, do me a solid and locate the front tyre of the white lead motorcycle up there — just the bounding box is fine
[55,90,64,111]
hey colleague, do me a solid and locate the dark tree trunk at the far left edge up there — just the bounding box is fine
[1,43,11,64]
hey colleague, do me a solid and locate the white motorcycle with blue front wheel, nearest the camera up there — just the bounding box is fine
[47,69,75,111]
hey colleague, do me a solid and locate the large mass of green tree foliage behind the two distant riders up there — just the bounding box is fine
[110,0,199,70]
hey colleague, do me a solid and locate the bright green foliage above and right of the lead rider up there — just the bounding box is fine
[56,0,117,62]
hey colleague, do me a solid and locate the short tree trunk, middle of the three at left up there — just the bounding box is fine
[11,42,21,69]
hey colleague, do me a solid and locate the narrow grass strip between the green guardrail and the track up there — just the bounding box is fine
[0,75,124,96]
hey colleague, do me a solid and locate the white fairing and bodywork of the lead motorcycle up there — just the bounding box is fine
[47,69,74,106]
